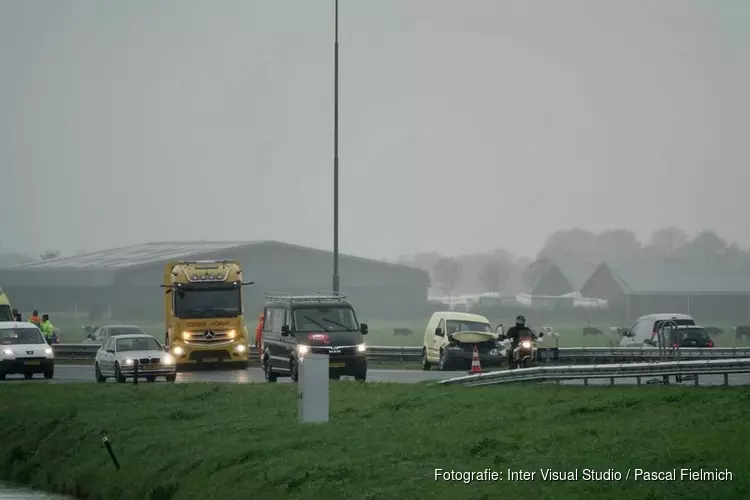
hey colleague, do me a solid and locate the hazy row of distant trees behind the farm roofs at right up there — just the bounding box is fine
[397,227,750,295]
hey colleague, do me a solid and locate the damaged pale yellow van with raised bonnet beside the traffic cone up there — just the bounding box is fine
[422,311,505,370]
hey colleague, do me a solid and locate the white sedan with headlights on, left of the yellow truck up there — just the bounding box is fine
[94,333,177,383]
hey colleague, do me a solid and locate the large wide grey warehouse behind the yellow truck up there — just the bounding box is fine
[0,241,430,319]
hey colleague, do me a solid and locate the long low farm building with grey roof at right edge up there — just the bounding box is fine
[581,262,750,325]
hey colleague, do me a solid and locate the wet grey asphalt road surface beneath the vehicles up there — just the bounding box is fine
[7,364,750,386]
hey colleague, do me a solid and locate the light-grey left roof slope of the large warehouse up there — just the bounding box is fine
[12,241,254,269]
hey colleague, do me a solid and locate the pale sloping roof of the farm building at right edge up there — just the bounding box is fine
[605,262,750,294]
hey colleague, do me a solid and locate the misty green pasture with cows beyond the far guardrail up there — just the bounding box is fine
[47,317,750,347]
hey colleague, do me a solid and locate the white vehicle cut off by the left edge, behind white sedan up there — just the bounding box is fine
[0,321,55,380]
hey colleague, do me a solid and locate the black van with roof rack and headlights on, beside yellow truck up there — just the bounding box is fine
[262,294,367,382]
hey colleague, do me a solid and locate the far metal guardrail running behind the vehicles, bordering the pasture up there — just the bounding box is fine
[52,344,750,365]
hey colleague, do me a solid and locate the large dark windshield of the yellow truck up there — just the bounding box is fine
[174,285,242,319]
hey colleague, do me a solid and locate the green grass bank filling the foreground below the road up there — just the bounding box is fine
[0,382,750,500]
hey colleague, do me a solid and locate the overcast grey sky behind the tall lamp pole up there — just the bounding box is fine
[0,0,750,257]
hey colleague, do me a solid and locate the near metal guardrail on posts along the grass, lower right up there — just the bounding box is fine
[440,358,750,387]
